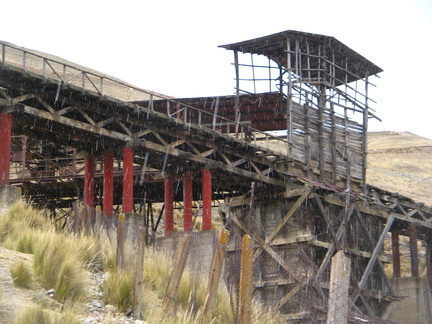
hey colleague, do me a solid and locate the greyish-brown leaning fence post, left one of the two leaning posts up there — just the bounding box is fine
[162,234,191,310]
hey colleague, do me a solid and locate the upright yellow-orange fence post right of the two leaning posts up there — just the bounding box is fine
[238,234,254,324]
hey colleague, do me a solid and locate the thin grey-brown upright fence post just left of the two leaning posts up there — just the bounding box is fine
[133,227,146,319]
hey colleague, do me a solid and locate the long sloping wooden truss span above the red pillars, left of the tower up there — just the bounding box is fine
[0,58,296,188]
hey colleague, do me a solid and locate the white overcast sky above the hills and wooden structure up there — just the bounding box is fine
[0,0,432,139]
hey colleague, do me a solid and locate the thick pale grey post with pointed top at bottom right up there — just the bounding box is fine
[327,250,351,324]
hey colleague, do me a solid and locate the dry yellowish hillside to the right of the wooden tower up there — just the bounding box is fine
[367,132,432,206]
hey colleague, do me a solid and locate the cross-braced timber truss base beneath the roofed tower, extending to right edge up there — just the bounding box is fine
[226,184,432,319]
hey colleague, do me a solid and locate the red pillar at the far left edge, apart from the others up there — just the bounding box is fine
[0,114,12,185]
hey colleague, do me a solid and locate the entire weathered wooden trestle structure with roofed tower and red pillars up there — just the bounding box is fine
[0,31,432,323]
